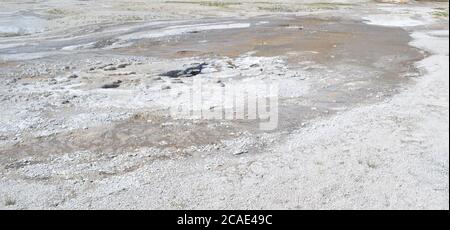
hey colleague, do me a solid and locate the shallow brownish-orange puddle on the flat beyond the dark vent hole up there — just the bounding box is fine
[112,18,417,65]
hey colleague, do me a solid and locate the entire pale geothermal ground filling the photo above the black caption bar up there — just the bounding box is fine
[0,0,449,209]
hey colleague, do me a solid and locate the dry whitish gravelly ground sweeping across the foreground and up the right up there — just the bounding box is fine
[0,1,449,209]
